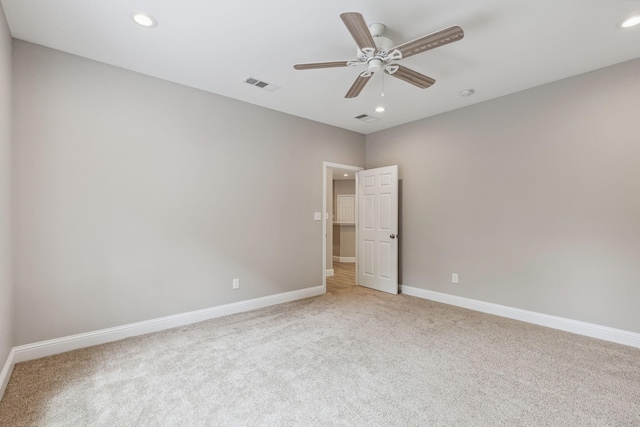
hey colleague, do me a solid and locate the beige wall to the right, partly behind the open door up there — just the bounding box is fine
[366,60,640,332]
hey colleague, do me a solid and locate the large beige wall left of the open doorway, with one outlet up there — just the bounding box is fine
[13,41,364,344]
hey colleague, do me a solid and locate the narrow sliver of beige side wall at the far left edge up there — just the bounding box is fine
[0,5,13,370]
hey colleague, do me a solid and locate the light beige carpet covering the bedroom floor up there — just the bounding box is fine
[0,276,640,426]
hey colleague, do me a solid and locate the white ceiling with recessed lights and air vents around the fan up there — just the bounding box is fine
[1,0,640,134]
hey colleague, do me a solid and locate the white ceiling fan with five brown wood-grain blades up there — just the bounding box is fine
[293,12,464,98]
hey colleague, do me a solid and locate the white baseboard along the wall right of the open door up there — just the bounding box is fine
[401,285,640,348]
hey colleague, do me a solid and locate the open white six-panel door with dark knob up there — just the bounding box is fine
[358,166,398,294]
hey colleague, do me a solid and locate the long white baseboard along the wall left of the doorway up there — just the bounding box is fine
[11,286,326,366]
